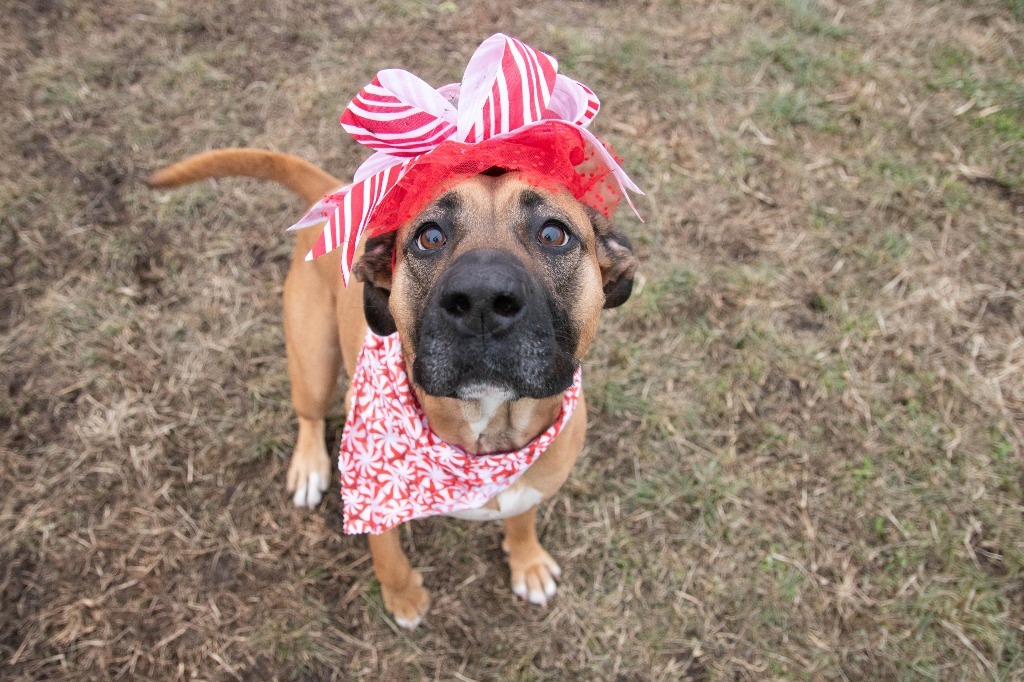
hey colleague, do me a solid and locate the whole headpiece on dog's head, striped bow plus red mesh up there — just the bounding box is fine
[289,33,643,285]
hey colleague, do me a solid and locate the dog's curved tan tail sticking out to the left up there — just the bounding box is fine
[147,148,344,204]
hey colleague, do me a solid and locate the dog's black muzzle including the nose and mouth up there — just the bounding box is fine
[413,249,579,399]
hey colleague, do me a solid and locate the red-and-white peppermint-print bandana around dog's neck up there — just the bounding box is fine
[338,331,582,535]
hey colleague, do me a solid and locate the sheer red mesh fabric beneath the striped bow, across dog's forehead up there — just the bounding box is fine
[367,121,622,236]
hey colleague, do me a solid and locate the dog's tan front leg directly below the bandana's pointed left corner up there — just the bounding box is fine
[370,526,430,630]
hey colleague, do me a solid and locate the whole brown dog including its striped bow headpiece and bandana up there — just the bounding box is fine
[150,33,642,628]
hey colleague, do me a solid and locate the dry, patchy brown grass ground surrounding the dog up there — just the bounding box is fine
[0,0,1024,680]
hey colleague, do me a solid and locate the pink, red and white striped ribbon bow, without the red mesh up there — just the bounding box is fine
[289,33,643,285]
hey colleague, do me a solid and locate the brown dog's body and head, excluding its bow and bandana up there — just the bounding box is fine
[150,150,637,628]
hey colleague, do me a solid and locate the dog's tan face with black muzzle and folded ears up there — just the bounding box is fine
[354,173,636,399]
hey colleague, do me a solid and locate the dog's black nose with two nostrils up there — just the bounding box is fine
[437,249,528,336]
